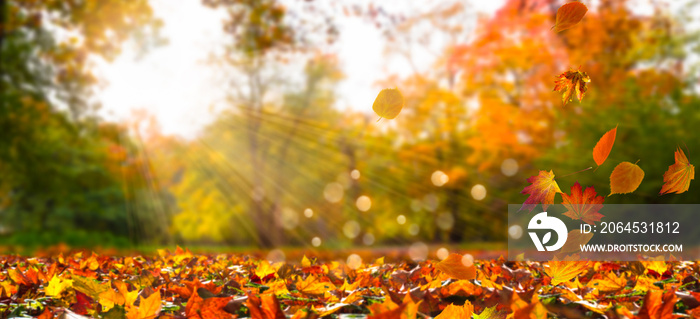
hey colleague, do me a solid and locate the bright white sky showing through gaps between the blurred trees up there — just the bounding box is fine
[96,0,504,138]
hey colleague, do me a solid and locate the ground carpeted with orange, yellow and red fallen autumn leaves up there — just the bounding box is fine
[0,248,700,319]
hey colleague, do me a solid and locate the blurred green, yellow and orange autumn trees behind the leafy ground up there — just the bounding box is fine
[0,0,700,248]
